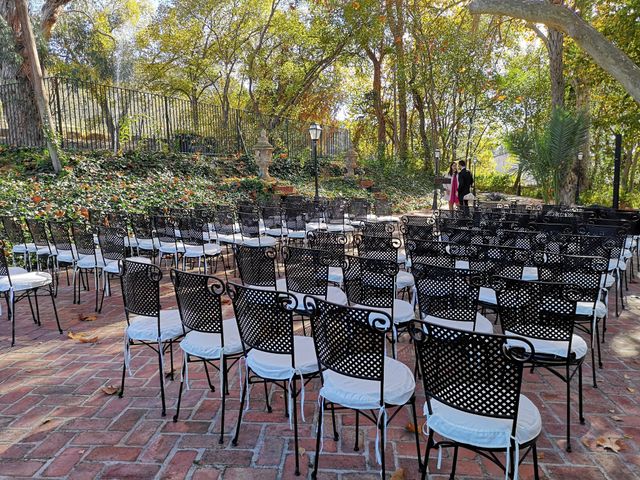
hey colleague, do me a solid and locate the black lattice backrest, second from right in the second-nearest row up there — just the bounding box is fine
[411,263,487,323]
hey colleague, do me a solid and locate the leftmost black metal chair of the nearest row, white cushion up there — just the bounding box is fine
[119,260,184,417]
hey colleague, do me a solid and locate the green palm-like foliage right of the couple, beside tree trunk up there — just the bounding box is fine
[506,108,589,204]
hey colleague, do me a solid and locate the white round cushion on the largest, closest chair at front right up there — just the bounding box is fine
[424,394,542,448]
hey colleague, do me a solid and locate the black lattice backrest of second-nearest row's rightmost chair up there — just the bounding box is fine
[492,277,581,352]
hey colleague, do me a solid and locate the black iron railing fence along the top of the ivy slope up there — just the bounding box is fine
[0,77,350,156]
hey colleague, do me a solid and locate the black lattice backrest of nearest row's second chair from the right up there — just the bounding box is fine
[305,297,391,390]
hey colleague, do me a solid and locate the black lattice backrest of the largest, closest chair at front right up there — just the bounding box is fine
[409,321,534,430]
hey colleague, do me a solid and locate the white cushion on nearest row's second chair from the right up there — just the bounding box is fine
[320,357,416,410]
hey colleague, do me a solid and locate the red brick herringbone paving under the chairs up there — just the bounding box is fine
[0,264,640,480]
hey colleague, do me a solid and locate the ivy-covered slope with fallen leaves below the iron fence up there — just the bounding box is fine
[0,146,438,218]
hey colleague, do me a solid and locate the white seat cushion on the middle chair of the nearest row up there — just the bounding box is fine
[247,336,318,380]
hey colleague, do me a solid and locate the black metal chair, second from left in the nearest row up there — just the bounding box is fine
[171,269,243,443]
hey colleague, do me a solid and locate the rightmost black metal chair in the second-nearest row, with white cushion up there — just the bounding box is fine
[492,277,588,452]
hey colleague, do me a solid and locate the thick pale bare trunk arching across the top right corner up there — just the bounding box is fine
[469,0,640,103]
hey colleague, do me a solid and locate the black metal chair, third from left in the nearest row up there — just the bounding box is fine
[227,283,318,475]
